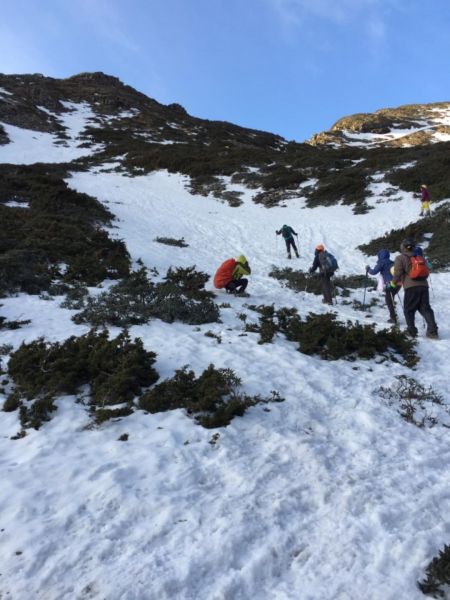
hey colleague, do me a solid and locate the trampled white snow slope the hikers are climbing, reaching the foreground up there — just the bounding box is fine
[0,144,450,600]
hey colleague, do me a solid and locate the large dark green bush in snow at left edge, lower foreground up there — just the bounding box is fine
[3,330,158,429]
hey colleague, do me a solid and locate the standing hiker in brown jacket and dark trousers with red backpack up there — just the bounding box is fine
[389,239,438,339]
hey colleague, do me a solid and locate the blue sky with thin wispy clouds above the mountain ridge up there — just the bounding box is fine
[0,0,450,141]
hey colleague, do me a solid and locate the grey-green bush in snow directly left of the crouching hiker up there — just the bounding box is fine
[73,267,219,327]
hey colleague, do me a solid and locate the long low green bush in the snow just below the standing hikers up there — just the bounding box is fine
[245,305,418,367]
